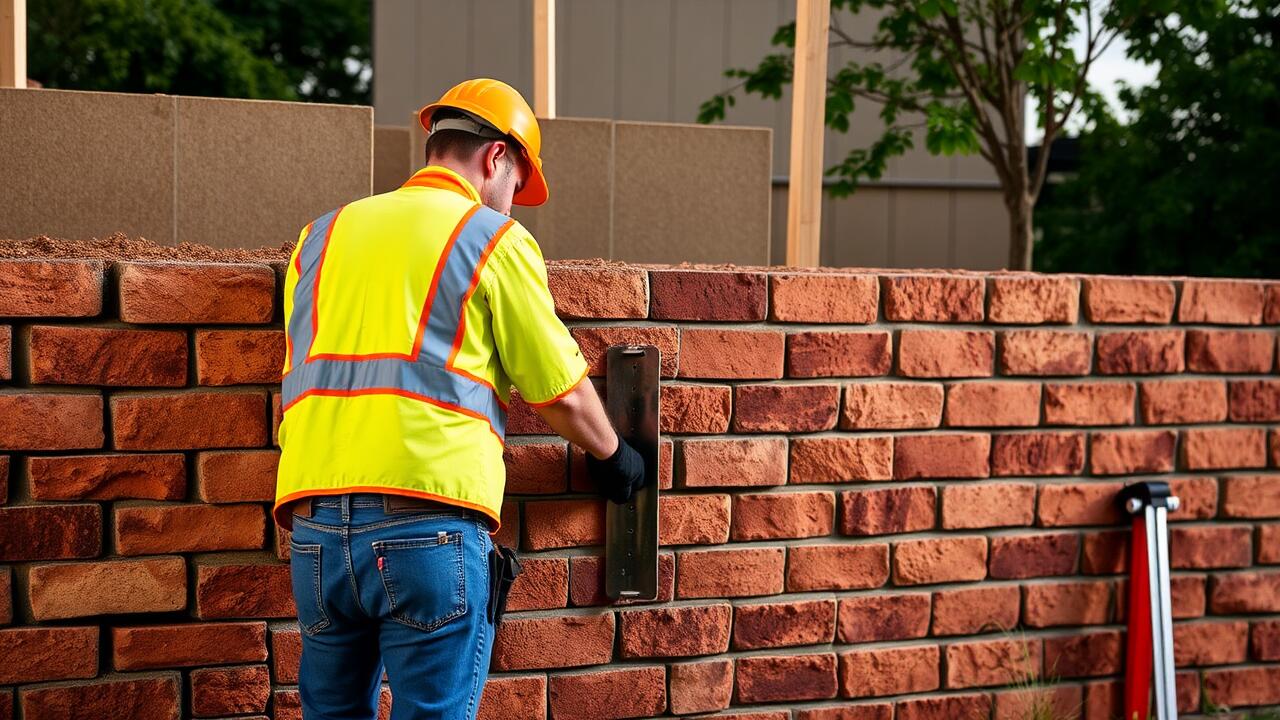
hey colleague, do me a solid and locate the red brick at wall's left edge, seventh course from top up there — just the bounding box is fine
[0,626,99,685]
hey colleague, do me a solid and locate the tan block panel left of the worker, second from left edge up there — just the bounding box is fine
[175,97,374,247]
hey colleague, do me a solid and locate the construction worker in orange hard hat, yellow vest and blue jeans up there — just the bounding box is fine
[273,79,645,720]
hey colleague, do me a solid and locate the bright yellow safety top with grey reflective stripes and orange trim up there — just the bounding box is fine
[273,167,586,533]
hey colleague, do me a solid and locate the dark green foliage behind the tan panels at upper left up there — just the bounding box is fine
[28,0,370,102]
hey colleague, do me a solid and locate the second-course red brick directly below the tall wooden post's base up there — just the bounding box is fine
[787,331,893,378]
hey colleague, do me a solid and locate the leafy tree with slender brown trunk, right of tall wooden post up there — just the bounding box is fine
[698,0,1144,269]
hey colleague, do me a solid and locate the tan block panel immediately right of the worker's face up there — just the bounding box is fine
[513,119,613,260]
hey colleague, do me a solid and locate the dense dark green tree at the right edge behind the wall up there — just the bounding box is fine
[1037,0,1280,277]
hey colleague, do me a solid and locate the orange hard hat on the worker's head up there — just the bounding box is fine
[417,78,548,205]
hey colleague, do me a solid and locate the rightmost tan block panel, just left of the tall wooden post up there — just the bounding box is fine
[613,122,772,265]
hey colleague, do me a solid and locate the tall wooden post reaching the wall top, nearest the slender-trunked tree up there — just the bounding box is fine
[787,0,831,268]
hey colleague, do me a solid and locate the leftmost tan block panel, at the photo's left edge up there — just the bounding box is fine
[0,90,174,243]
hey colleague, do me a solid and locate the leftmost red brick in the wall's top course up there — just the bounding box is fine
[0,260,102,318]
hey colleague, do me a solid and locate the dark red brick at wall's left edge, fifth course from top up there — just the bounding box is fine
[0,505,102,562]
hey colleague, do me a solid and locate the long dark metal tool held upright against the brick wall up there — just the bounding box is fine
[604,345,662,600]
